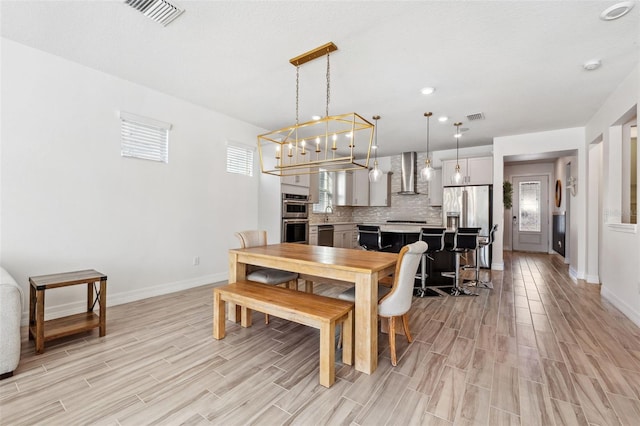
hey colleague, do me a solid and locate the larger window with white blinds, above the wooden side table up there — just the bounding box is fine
[120,112,171,163]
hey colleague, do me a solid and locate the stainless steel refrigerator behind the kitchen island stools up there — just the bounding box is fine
[442,185,493,268]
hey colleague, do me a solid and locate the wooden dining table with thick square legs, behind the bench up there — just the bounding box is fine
[229,243,398,374]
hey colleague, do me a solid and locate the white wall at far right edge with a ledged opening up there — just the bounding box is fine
[586,67,640,325]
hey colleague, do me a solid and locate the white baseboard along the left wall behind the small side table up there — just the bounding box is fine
[21,273,229,326]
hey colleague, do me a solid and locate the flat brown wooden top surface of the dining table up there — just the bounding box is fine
[229,243,398,273]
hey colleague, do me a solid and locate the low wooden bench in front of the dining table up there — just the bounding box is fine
[213,281,353,387]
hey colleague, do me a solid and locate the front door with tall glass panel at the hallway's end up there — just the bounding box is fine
[512,176,549,253]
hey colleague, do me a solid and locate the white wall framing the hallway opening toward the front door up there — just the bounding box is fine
[492,128,587,279]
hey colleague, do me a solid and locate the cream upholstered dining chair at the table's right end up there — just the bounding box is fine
[338,241,428,366]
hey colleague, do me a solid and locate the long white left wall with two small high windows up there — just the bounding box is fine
[0,39,277,322]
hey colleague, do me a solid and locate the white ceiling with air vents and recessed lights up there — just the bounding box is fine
[0,0,640,156]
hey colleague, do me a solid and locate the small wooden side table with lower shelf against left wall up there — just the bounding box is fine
[29,269,107,354]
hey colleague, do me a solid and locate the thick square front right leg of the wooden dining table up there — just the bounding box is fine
[355,272,378,374]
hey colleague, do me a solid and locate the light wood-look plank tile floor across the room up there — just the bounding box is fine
[0,253,640,425]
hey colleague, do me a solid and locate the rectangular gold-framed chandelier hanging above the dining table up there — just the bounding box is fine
[258,43,374,176]
